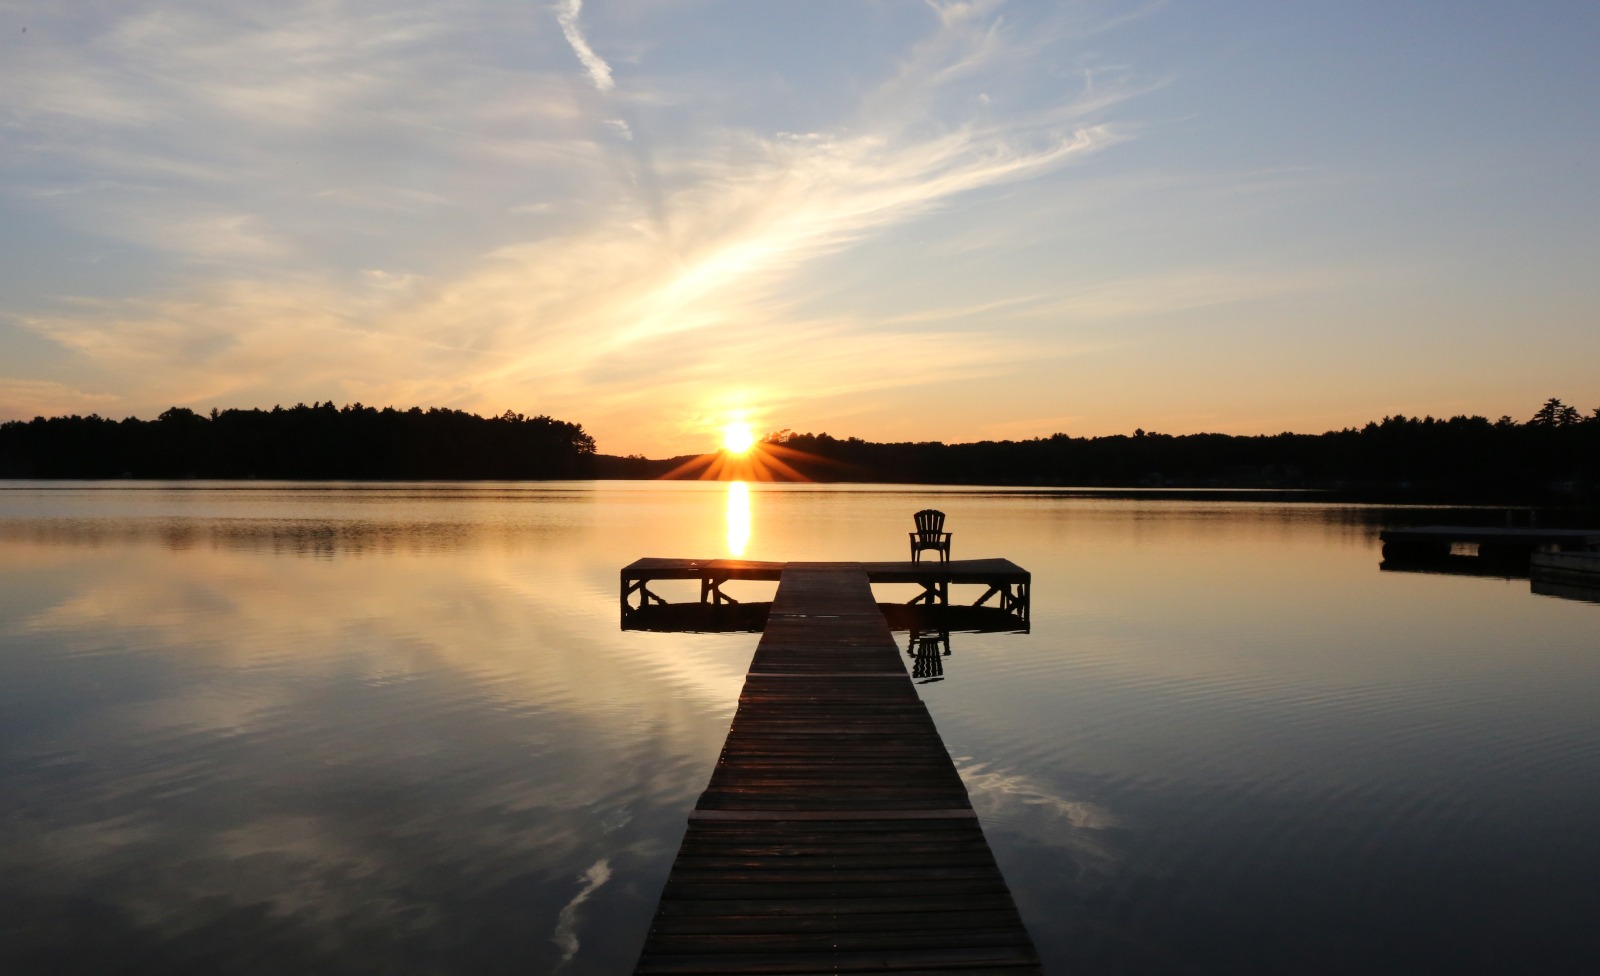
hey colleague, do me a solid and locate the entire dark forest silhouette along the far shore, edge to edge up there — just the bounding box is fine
[0,398,1600,502]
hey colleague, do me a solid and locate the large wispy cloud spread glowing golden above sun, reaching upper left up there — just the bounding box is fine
[0,0,1152,451]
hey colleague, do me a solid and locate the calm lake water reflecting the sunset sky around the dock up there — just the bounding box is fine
[0,482,1600,974]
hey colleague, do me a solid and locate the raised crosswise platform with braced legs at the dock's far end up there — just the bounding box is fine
[619,557,1034,630]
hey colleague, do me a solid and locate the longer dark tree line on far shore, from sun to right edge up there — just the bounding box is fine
[597,398,1600,502]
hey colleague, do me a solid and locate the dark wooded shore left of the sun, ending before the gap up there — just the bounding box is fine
[0,400,595,480]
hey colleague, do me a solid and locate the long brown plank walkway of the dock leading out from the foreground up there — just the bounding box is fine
[624,560,1040,976]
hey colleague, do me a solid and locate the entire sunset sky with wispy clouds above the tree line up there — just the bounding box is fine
[0,0,1600,458]
